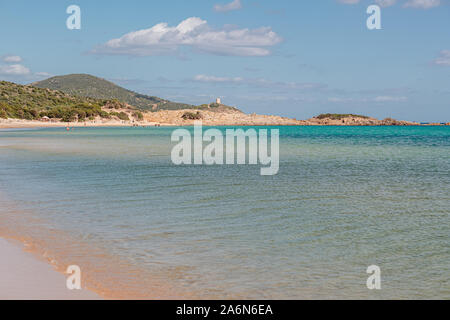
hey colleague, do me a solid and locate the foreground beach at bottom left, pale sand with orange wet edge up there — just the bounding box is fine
[0,190,198,300]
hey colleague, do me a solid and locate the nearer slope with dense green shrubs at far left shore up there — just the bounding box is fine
[0,81,142,122]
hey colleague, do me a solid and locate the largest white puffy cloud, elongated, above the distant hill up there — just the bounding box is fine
[92,17,282,56]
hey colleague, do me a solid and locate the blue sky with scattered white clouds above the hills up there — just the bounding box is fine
[0,0,450,122]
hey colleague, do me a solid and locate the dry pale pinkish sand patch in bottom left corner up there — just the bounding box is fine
[0,238,101,300]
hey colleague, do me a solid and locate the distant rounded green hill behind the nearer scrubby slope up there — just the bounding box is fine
[32,74,193,111]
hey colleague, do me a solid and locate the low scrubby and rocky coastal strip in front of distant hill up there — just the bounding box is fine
[0,81,440,126]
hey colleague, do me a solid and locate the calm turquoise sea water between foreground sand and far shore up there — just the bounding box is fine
[0,127,450,299]
